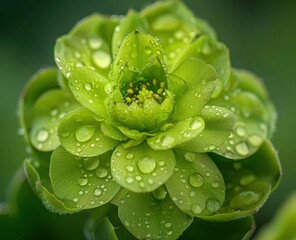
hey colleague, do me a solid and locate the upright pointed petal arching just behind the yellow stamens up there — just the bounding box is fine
[111,30,165,80]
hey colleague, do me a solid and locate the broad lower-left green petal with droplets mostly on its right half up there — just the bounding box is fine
[50,147,120,209]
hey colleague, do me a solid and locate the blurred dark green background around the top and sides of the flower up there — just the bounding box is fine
[0,0,296,236]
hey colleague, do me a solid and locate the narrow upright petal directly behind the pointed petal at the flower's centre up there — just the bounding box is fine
[112,10,148,57]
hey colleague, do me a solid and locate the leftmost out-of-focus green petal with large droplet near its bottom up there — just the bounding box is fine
[30,90,81,151]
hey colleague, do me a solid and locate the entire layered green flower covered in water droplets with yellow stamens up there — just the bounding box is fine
[20,0,281,239]
